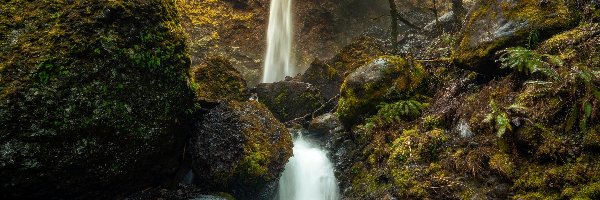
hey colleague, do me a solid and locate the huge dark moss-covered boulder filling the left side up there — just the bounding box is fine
[0,0,193,199]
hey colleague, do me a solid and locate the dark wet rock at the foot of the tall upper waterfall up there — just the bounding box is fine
[254,81,325,122]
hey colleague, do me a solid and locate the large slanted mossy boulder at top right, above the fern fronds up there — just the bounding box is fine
[453,0,578,73]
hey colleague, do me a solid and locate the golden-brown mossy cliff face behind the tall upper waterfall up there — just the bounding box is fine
[176,0,389,86]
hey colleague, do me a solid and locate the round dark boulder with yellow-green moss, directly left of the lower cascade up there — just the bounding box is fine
[190,101,292,199]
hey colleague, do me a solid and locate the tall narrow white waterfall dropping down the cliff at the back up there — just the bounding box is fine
[262,0,295,83]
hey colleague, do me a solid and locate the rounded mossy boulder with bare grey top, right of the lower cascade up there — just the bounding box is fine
[336,56,427,127]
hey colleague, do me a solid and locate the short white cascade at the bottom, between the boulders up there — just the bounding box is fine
[278,135,340,200]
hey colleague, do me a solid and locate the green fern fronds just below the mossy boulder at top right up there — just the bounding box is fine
[498,47,563,79]
